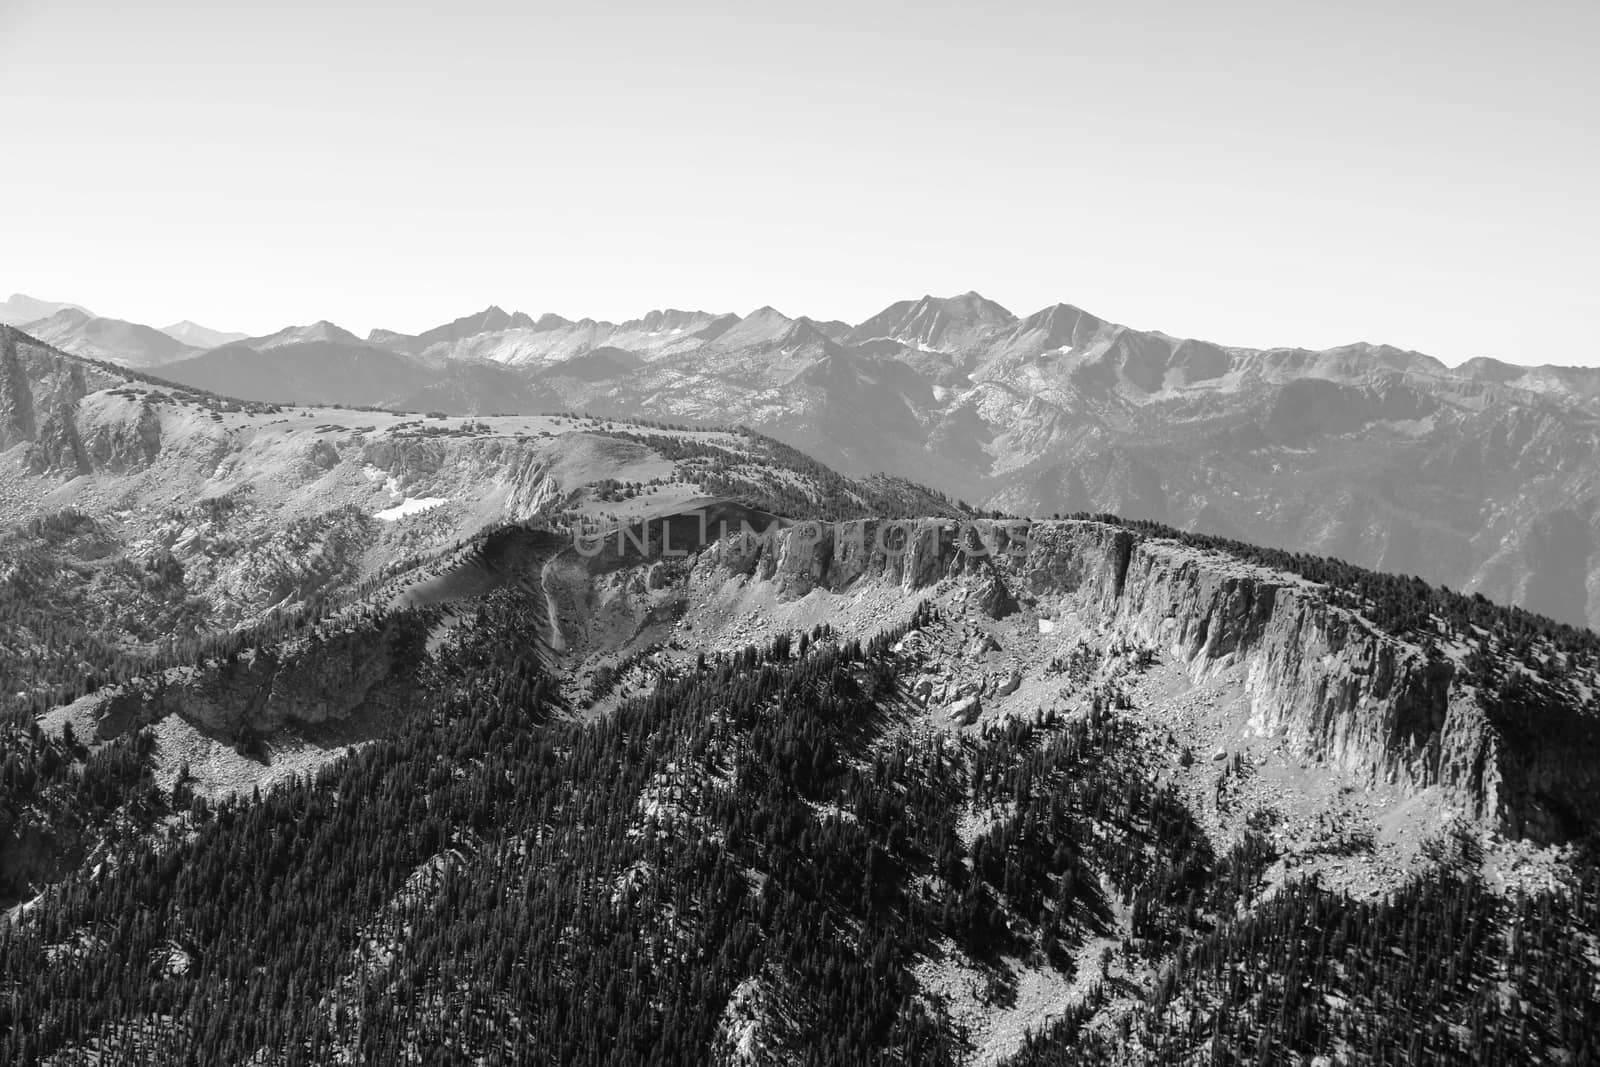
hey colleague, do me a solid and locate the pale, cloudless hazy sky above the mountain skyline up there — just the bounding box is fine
[0,0,1600,363]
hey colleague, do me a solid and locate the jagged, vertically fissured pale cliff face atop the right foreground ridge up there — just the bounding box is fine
[704,522,1600,840]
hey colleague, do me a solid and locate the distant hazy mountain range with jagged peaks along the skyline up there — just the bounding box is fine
[13,293,1600,625]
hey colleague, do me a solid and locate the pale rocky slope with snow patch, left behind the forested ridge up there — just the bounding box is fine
[0,321,949,709]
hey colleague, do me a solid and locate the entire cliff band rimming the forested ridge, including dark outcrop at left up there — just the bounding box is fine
[53,509,1600,841]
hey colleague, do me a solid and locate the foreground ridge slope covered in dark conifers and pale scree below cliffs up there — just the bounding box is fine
[0,510,1600,1064]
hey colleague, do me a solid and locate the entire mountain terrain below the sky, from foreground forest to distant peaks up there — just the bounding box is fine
[0,321,1600,1067]
